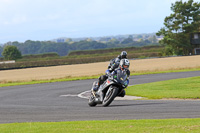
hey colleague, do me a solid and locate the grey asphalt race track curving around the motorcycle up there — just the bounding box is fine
[0,71,200,123]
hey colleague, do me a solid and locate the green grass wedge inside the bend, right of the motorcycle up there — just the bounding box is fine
[126,76,200,99]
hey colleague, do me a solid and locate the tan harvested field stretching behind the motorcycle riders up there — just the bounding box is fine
[0,55,200,82]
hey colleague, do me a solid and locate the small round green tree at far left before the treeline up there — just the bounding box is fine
[2,45,22,60]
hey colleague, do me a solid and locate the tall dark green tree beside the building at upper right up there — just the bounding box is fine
[157,0,200,55]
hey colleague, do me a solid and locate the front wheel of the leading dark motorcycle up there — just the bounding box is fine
[103,86,119,107]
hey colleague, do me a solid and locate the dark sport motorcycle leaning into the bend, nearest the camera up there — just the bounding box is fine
[88,70,128,107]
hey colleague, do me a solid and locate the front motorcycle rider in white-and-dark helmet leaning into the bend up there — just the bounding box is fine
[93,59,130,97]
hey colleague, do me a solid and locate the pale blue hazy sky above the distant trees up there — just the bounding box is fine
[0,0,191,44]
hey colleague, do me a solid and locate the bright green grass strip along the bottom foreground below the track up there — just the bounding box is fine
[0,118,200,133]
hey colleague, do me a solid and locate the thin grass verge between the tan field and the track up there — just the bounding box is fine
[0,68,200,87]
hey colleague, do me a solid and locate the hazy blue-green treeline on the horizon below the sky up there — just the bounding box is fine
[0,38,157,56]
